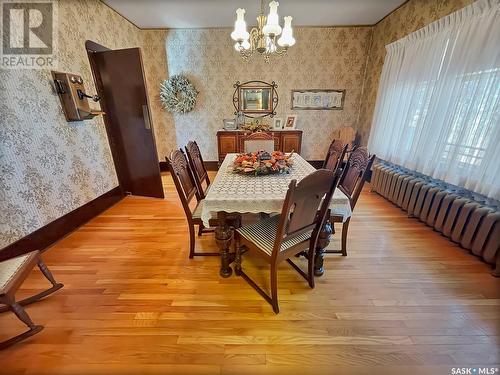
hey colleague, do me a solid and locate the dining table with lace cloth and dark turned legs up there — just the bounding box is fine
[201,153,352,277]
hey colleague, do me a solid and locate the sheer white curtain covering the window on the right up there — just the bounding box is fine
[368,0,500,199]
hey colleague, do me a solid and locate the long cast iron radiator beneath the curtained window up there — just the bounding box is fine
[371,159,500,276]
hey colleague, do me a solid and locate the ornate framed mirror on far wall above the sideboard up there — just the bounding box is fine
[233,81,278,118]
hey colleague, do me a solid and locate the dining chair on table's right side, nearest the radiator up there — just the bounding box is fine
[324,147,375,256]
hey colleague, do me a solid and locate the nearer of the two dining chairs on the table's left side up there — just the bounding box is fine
[165,149,241,258]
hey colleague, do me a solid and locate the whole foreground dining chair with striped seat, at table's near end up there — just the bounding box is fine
[235,169,339,314]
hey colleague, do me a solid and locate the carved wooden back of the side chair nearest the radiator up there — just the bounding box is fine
[339,147,375,209]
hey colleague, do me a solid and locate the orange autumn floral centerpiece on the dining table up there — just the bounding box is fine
[233,151,293,176]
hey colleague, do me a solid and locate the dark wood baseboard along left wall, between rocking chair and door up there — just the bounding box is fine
[0,186,124,261]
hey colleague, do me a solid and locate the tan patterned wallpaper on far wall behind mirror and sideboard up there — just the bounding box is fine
[167,27,371,160]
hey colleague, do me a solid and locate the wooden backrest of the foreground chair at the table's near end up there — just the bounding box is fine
[273,169,339,259]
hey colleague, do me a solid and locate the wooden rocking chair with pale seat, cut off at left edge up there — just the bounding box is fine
[0,250,63,350]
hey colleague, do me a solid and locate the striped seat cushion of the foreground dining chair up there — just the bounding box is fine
[236,215,312,255]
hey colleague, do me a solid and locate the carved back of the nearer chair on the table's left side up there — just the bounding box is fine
[165,149,201,221]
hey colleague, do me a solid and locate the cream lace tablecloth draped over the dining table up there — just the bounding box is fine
[201,154,352,227]
